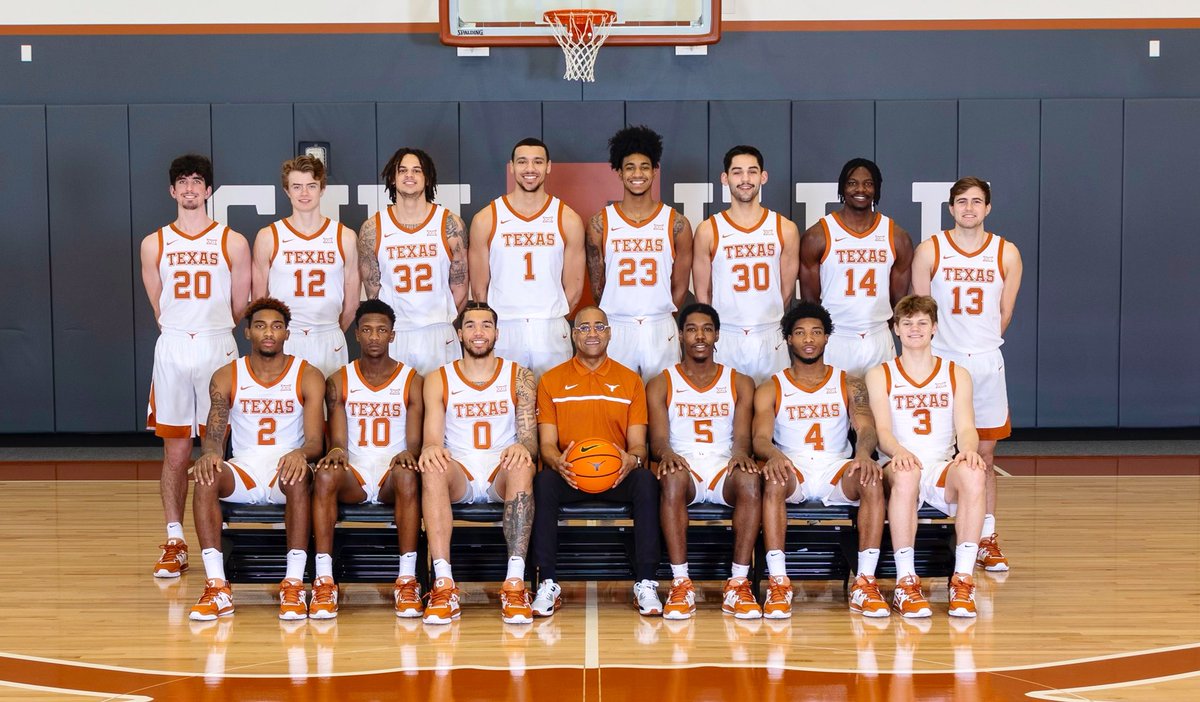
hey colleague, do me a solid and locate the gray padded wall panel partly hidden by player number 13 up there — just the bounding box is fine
[947,100,1040,426]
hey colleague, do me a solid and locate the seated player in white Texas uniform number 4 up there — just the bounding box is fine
[754,302,892,618]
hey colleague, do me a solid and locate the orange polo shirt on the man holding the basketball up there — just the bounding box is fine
[538,356,648,451]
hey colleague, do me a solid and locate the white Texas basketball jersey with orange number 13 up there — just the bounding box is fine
[929,232,1006,354]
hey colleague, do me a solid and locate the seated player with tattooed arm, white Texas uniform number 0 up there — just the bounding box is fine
[420,302,538,624]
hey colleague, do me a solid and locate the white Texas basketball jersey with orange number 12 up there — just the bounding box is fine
[266,217,346,329]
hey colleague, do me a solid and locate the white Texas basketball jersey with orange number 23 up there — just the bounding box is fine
[600,203,678,319]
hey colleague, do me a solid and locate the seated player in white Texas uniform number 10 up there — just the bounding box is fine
[308,300,422,619]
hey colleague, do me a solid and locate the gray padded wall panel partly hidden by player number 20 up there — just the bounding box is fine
[130,104,212,428]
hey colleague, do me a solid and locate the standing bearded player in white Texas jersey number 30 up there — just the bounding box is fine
[691,146,800,383]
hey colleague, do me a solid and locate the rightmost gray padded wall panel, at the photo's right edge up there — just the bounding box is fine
[1100,100,1200,426]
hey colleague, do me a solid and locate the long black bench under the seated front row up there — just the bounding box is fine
[221,502,955,583]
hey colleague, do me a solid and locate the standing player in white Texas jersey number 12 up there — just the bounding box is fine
[252,156,359,377]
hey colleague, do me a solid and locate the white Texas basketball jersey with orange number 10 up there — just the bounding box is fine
[338,361,415,466]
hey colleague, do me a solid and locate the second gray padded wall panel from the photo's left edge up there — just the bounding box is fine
[46,106,133,432]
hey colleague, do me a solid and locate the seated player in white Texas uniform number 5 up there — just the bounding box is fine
[646,302,762,619]
